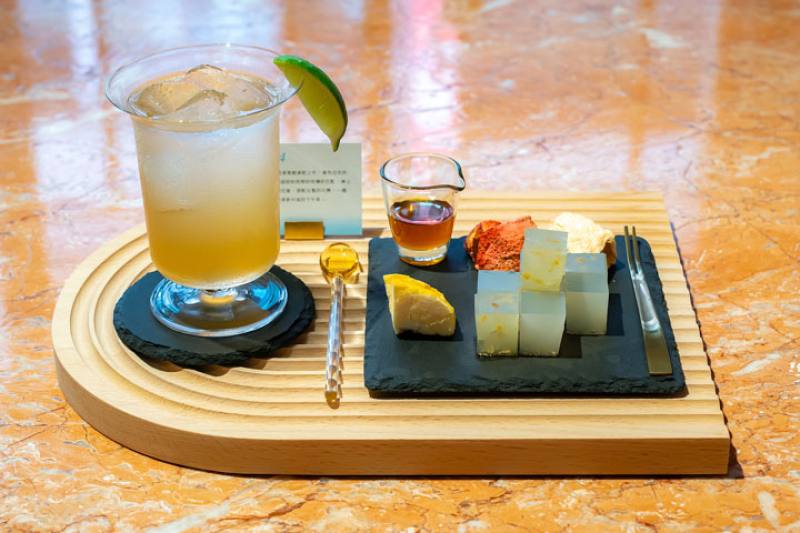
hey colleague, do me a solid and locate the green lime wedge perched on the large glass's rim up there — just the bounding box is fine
[273,55,347,152]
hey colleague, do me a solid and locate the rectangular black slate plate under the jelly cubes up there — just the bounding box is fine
[364,237,685,396]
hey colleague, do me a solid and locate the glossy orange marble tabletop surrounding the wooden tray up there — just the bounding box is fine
[0,0,800,531]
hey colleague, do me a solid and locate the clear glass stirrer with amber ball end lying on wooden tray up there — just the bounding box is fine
[319,242,361,408]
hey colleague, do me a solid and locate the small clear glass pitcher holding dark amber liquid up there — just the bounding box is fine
[381,152,466,266]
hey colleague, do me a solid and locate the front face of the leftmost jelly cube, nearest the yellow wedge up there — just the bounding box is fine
[475,292,519,355]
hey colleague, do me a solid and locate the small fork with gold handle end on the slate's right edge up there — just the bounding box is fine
[625,226,672,376]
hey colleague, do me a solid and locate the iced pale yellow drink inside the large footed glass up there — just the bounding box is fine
[130,65,280,289]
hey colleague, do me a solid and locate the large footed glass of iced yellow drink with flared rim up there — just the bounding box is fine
[106,44,297,337]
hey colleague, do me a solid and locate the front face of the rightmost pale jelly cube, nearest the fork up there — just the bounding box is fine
[564,276,608,335]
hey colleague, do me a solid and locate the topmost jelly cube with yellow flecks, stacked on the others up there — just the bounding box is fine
[520,228,567,291]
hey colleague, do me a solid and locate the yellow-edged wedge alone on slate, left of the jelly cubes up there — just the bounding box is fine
[383,274,456,337]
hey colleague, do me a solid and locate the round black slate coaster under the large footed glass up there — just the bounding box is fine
[114,266,316,366]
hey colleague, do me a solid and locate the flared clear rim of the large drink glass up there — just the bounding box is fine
[103,42,296,126]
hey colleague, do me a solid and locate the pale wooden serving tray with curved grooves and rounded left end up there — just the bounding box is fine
[53,193,730,475]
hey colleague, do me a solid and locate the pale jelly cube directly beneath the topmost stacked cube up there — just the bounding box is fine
[519,291,567,355]
